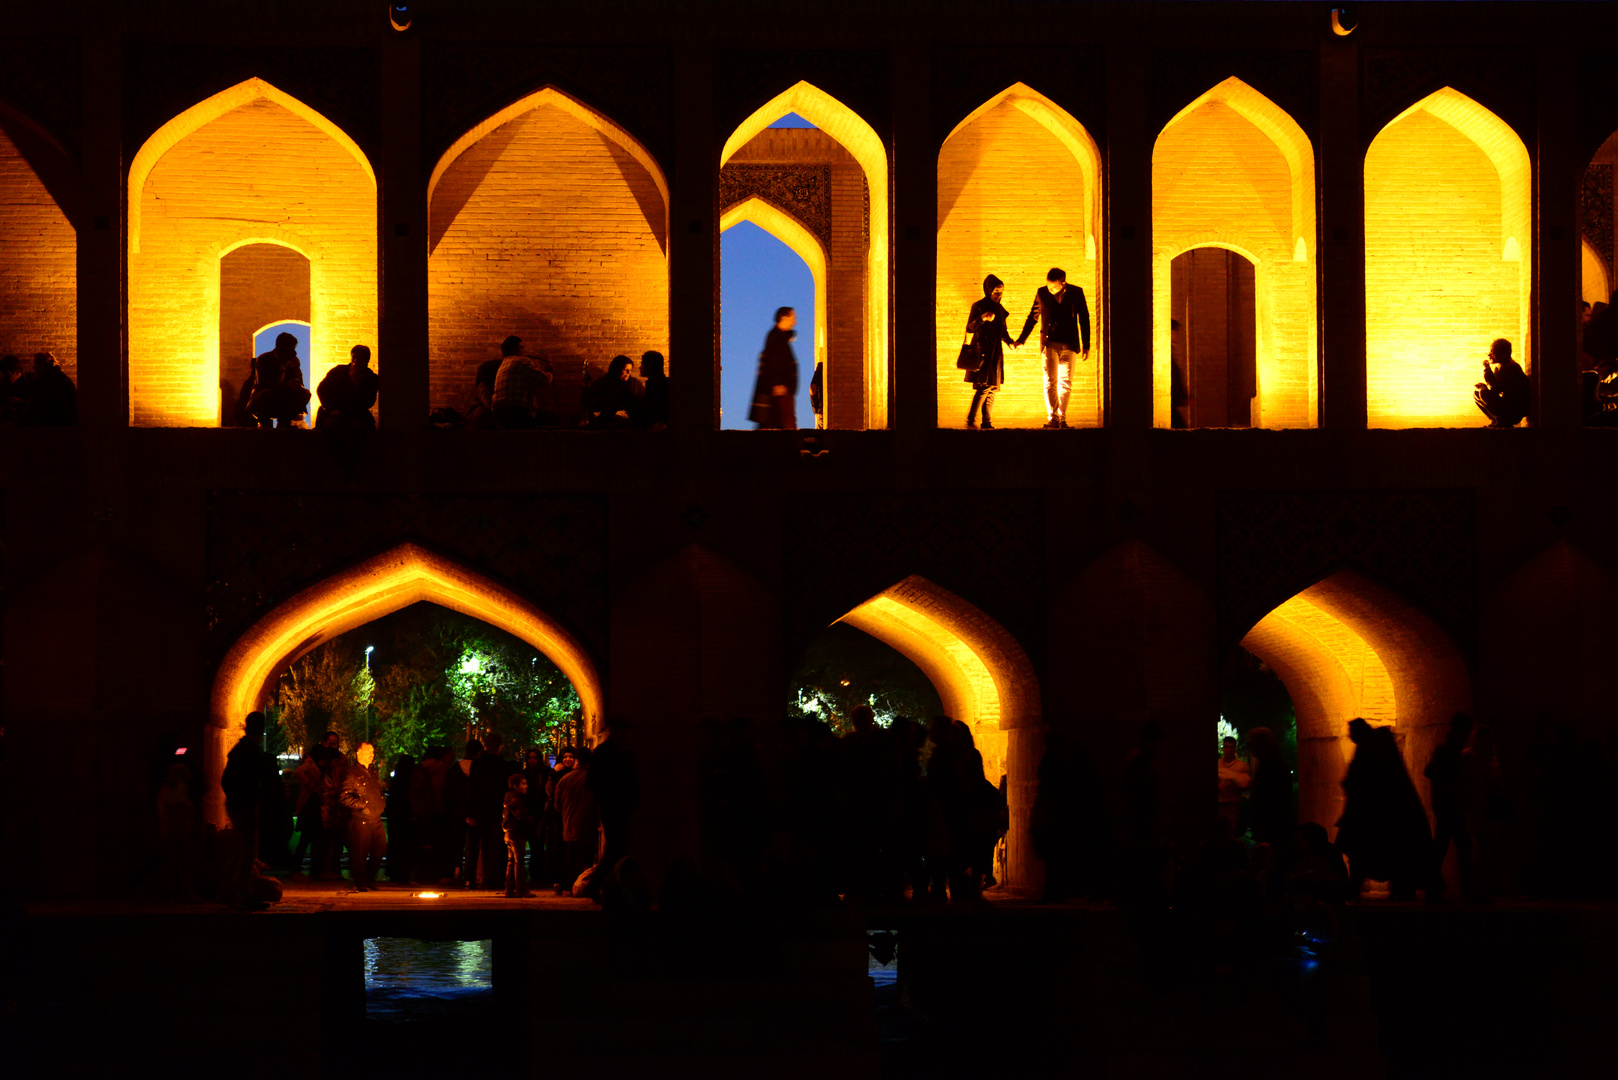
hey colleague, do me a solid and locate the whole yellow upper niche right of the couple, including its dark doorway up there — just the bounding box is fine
[1152,78,1319,427]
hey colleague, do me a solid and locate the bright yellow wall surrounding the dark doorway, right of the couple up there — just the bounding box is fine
[1152,78,1319,427]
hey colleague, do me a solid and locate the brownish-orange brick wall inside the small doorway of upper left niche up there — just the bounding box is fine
[218,244,309,390]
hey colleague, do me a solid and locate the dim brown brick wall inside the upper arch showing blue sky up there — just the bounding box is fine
[720,128,869,427]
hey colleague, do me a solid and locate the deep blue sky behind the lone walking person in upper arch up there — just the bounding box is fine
[718,113,814,431]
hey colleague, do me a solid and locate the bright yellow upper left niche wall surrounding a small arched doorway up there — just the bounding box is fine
[128,78,380,426]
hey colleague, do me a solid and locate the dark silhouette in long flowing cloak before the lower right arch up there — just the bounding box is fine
[1336,717,1432,900]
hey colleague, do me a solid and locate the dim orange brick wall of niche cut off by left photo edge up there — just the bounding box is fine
[0,131,78,376]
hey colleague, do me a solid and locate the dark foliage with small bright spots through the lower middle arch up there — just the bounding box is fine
[786,623,943,735]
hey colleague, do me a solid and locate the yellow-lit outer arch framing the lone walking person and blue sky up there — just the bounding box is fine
[718,83,888,427]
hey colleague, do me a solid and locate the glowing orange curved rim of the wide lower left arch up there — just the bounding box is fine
[205,544,602,824]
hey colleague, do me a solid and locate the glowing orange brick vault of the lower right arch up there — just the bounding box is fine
[1241,570,1472,832]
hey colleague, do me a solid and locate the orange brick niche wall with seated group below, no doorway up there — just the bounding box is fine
[427,105,678,418]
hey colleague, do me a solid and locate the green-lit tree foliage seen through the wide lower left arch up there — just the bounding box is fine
[282,604,579,761]
